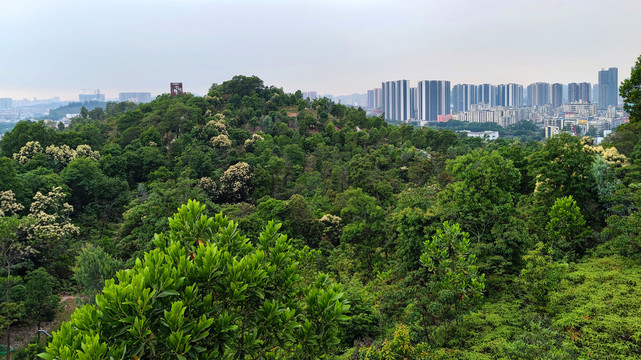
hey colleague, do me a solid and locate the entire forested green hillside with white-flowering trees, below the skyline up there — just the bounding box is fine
[0,58,641,359]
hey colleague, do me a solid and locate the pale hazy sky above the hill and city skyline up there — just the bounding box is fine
[0,0,641,99]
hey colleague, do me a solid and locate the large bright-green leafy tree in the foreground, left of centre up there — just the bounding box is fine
[44,201,349,359]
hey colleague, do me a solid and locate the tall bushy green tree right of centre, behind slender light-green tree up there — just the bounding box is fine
[438,150,526,274]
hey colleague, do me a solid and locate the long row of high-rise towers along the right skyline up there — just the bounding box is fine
[367,68,619,121]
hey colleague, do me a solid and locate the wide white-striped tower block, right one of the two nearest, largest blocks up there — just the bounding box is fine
[418,80,451,121]
